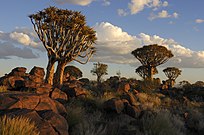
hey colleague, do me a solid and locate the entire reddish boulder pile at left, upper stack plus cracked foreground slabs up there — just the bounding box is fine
[0,67,68,135]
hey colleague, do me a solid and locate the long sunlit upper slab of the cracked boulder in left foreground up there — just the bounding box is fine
[0,91,66,113]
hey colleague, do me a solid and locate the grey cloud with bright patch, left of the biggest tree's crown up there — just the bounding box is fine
[0,28,44,59]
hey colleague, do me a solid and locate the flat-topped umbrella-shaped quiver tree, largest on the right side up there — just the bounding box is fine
[131,44,173,80]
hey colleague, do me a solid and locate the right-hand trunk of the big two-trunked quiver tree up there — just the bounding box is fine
[56,61,66,86]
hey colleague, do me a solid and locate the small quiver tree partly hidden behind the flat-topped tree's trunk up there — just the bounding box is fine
[135,66,158,80]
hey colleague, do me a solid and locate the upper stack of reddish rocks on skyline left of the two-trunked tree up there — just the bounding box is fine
[0,67,45,91]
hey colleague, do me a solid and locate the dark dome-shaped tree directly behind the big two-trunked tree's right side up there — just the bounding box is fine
[64,66,83,81]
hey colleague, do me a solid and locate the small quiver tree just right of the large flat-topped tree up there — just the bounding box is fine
[163,67,182,87]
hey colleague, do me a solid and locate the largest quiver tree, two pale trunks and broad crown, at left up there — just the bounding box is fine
[29,7,96,84]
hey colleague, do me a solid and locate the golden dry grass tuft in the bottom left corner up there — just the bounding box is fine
[0,115,39,135]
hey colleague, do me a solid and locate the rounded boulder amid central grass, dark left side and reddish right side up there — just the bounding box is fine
[103,98,125,113]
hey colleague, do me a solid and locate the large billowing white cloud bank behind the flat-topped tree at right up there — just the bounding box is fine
[92,22,204,68]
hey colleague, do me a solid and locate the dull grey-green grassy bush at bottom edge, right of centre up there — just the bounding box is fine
[141,110,185,135]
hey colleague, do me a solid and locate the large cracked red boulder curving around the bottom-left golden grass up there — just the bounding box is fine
[0,91,68,135]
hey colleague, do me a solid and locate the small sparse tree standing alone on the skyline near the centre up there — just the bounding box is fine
[91,62,108,84]
